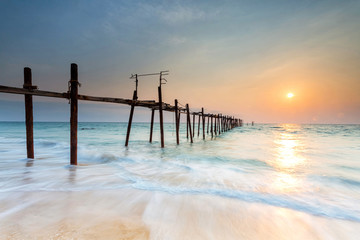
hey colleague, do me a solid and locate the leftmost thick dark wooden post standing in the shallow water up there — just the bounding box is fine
[23,67,34,158]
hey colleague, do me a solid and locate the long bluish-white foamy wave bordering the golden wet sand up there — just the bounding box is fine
[0,170,360,222]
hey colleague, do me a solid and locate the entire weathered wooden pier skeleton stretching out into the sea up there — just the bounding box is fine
[0,63,242,165]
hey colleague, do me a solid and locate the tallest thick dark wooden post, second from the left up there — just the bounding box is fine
[70,63,79,165]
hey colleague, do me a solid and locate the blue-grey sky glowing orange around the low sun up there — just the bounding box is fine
[0,0,360,123]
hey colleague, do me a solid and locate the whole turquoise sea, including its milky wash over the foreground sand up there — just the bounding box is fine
[0,122,360,240]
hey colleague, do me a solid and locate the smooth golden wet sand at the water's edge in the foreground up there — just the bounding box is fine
[0,189,360,240]
